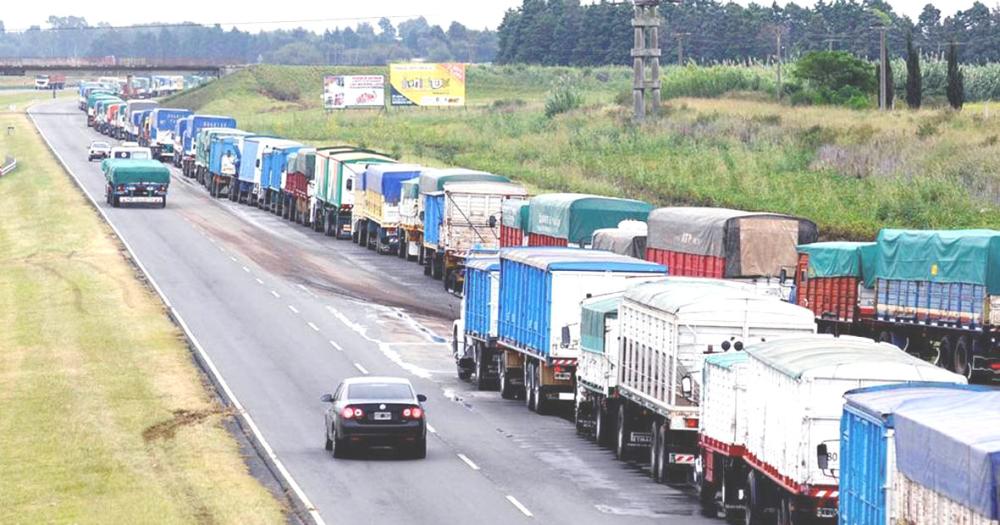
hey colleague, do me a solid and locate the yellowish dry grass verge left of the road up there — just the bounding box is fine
[0,94,284,523]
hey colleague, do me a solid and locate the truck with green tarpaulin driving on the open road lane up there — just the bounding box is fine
[101,159,170,208]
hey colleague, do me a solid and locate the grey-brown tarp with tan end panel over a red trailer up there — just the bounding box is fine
[647,207,818,278]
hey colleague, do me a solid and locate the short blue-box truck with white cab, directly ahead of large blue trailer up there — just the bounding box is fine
[451,253,500,390]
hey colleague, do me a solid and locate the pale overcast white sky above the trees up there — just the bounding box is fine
[0,0,995,32]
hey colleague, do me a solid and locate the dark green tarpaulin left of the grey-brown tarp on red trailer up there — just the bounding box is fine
[528,193,653,244]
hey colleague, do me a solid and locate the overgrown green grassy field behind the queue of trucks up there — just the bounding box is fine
[168,66,1000,239]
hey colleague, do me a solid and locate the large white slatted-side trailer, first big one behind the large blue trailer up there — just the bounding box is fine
[612,277,816,483]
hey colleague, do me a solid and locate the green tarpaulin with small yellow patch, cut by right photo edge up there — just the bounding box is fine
[874,229,1000,295]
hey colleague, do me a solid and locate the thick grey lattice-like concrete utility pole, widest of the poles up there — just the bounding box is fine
[632,0,660,122]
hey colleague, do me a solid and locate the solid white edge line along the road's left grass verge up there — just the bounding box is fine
[28,110,326,525]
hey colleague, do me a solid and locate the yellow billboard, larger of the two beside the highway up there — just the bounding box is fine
[389,64,465,106]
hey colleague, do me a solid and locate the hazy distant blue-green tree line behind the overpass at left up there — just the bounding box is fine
[0,16,497,65]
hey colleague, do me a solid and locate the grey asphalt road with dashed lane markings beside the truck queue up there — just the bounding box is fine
[31,100,720,525]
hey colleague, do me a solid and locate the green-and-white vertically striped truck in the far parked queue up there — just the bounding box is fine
[312,146,396,237]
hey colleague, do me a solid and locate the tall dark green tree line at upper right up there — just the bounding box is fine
[496,0,1000,66]
